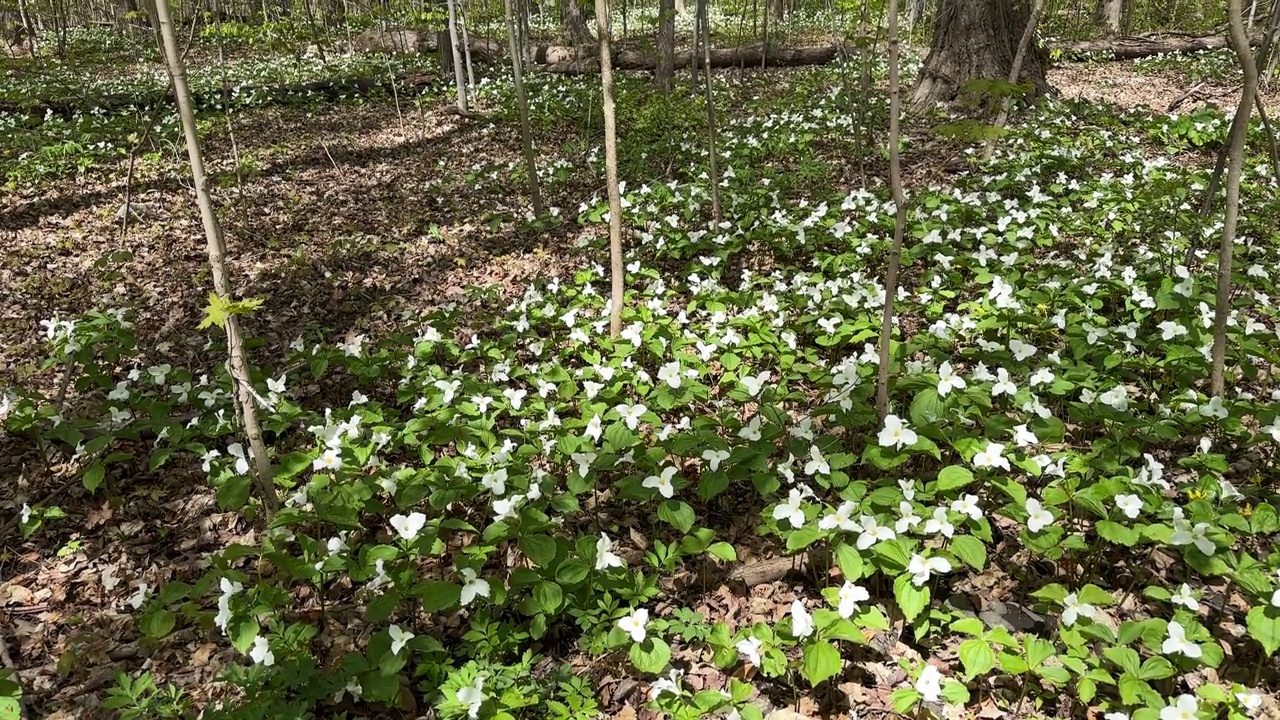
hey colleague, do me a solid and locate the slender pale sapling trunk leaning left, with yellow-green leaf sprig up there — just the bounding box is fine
[156,0,279,519]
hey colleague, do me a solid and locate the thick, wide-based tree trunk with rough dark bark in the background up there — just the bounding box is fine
[911,0,1048,111]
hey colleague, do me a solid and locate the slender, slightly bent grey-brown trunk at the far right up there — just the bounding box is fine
[1210,0,1258,397]
